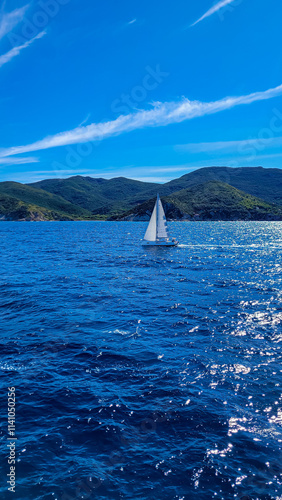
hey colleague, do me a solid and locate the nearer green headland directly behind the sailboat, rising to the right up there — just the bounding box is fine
[115,181,282,220]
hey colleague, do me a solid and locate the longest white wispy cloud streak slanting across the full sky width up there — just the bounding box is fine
[0,85,282,158]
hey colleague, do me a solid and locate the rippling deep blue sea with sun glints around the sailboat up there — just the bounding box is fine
[0,222,282,500]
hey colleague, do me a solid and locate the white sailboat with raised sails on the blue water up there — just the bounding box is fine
[142,195,178,247]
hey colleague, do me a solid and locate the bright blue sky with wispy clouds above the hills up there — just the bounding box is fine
[0,0,282,182]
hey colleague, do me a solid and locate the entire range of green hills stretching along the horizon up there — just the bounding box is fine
[0,167,282,220]
